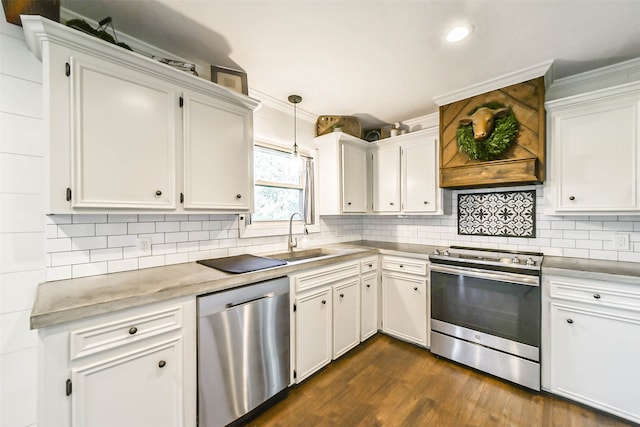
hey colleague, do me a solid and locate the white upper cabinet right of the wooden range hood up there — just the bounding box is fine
[545,60,640,215]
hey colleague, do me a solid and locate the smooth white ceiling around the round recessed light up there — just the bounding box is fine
[62,0,640,127]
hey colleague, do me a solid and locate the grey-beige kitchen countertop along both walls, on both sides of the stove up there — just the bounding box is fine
[31,240,640,329]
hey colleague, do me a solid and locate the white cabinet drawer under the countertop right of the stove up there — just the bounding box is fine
[549,277,640,311]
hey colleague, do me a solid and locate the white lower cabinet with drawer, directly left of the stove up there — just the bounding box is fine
[382,257,429,347]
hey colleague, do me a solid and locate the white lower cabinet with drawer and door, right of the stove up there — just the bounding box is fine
[543,276,640,423]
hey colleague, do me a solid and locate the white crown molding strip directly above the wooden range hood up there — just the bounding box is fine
[433,61,553,106]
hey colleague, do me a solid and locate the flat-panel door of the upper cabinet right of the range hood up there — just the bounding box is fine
[551,99,640,212]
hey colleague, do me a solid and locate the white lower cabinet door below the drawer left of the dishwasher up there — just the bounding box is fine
[71,338,184,427]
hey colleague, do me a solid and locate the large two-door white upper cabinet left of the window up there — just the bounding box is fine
[22,16,259,213]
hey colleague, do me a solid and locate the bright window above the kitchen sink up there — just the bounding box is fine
[240,142,316,237]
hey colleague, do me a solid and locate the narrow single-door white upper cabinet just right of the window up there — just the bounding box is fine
[314,132,371,215]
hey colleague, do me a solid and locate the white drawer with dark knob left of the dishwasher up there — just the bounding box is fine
[70,305,183,360]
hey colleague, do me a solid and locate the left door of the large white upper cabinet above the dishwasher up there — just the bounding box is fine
[70,54,179,209]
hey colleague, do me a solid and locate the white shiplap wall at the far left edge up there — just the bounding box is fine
[0,15,46,427]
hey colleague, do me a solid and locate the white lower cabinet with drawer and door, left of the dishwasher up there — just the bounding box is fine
[38,297,197,427]
